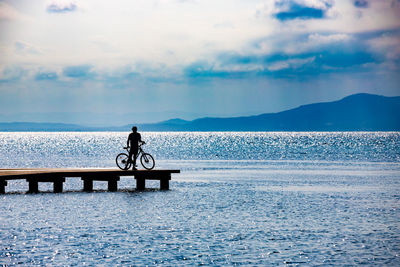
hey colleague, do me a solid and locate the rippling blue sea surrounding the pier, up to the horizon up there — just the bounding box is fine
[0,132,400,266]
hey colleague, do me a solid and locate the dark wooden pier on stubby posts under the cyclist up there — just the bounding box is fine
[0,169,180,194]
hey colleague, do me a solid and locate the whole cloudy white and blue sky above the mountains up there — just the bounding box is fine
[0,0,400,122]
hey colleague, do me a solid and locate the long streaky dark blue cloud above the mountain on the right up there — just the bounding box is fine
[184,37,383,78]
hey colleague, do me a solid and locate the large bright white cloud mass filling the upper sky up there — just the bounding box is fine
[0,0,394,75]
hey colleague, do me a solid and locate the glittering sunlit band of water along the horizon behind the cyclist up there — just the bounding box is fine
[0,132,400,168]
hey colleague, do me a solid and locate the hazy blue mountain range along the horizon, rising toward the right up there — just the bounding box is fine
[0,94,400,131]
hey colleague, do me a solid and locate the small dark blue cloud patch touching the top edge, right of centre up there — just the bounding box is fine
[273,0,332,21]
